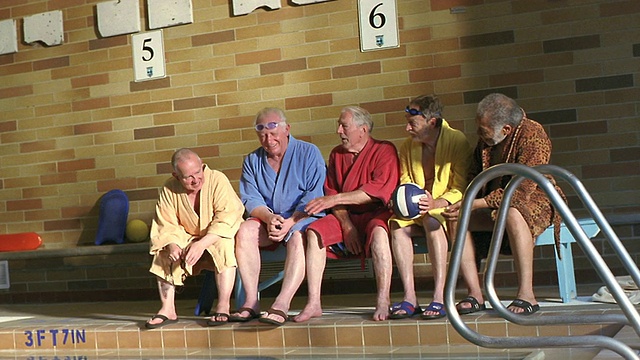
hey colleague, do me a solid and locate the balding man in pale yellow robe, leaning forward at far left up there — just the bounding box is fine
[146,149,244,329]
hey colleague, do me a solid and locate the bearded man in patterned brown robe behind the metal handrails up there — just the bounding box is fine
[443,94,564,315]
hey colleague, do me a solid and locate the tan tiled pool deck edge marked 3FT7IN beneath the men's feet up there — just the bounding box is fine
[0,288,640,360]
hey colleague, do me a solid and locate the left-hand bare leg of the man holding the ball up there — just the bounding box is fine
[390,222,418,314]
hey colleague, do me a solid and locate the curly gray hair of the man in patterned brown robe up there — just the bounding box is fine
[476,93,524,130]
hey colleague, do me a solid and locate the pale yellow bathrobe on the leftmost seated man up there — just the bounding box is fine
[149,165,244,286]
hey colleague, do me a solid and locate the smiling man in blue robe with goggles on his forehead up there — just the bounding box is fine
[229,108,326,325]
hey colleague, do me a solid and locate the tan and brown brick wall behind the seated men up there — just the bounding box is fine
[0,0,640,298]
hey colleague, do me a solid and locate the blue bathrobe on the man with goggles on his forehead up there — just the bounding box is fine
[240,135,327,241]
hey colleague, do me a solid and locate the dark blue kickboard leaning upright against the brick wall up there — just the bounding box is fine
[96,189,129,245]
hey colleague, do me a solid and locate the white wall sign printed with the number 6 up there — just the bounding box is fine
[358,0,400,51]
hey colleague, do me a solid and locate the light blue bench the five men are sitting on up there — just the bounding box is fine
[195,219,600,316]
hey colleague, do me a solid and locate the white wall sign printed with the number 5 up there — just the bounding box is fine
[131,30,166,81]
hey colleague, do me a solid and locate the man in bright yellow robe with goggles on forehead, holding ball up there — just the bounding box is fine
[389,95,472,320]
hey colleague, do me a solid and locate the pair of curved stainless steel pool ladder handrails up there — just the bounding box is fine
[445,164,640,359]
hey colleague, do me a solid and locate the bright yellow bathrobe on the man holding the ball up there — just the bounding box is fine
[389,119,472,227]
